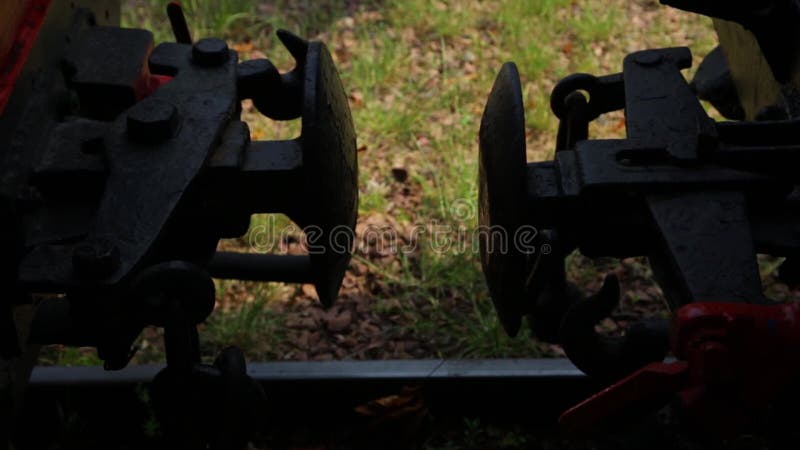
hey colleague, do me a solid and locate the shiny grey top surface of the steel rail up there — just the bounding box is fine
[30,358,585,387]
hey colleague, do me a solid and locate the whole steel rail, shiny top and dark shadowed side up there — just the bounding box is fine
[28,358,599,426]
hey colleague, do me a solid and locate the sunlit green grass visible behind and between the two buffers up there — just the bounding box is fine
[34,0,715,368]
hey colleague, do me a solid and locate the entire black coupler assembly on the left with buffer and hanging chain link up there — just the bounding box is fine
[0,1,358,448]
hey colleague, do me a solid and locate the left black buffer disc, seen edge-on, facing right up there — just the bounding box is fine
[302,42,358,305]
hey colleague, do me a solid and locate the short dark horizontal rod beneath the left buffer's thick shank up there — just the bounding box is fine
[208,252,312,283]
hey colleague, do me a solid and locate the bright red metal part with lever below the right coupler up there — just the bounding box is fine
[559,303,800,434]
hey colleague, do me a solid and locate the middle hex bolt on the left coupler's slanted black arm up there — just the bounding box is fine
[127,97,178,144]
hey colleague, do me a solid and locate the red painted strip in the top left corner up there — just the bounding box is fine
[0,0,51,114]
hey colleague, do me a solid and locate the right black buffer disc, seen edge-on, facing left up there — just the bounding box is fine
[478,63,526,336]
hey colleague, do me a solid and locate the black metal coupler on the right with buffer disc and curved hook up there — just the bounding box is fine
[480,48,800,380]
